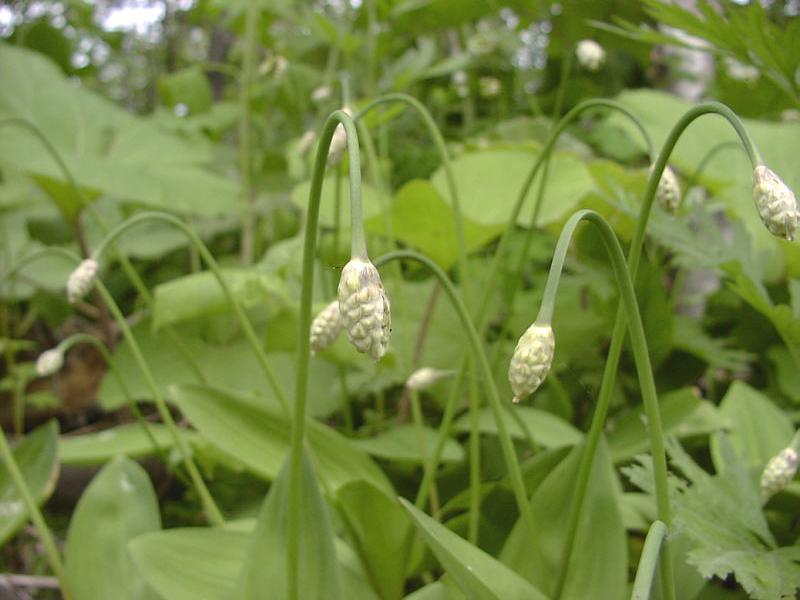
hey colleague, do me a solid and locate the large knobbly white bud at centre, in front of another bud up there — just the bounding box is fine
[339,258,391,360]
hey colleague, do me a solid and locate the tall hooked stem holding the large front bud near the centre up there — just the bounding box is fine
[286,110,369,600]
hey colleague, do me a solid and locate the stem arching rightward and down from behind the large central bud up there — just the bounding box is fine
[375,250,539,564]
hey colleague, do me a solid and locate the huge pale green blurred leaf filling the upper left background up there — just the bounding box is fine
[0,44,240,219]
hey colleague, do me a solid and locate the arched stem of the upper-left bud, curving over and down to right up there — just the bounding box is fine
[92,212,289,413]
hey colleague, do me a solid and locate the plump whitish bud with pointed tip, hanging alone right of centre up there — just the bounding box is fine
[508,323,556,403]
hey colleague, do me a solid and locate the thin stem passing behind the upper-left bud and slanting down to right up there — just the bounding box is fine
[4,247,225,526]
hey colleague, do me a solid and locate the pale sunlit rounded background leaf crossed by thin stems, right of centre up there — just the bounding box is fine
[432,150,594,226]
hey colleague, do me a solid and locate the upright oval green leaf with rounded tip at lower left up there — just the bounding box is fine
[65,456,161,600]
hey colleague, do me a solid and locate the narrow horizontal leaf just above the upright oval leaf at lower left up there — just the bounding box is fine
[58,423,177,466]
